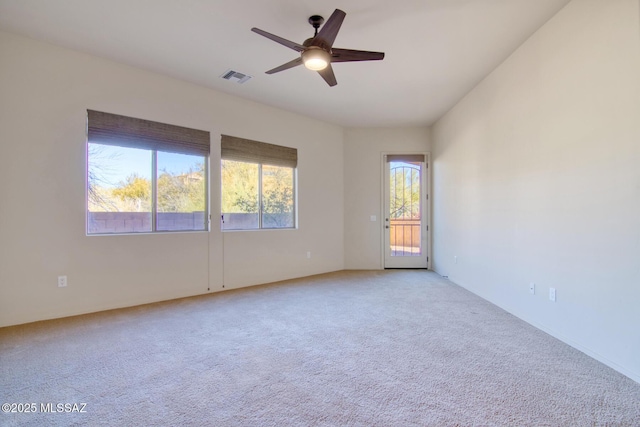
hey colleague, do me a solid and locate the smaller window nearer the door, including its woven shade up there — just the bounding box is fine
[221,135,298,230]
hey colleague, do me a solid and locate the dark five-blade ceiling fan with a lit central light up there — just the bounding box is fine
[251,9,384,86]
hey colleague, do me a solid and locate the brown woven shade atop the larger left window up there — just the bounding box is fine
[87,110,211,156]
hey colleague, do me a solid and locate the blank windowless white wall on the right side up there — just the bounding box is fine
[432,0,640,381]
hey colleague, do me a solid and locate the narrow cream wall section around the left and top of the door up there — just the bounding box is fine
[344,127,431,270]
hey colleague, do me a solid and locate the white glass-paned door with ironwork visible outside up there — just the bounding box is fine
[384,154,428,268]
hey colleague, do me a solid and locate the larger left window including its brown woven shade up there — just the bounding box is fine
[87,110,209,234]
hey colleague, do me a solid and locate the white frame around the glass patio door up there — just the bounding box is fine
[380,151,433,270]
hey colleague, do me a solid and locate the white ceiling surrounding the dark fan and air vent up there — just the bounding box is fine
[0,0,570,127]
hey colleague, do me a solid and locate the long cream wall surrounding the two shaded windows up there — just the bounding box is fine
[0,33,344,326]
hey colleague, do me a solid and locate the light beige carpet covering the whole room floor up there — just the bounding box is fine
[0,270,640,426]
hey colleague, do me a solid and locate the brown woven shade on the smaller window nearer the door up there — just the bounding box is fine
[220,135,298,168]
